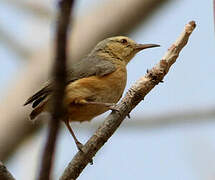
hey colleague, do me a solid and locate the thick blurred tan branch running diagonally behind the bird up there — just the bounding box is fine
[0,0,170,160]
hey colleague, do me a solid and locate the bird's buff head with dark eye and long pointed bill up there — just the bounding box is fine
[94,36,160,64]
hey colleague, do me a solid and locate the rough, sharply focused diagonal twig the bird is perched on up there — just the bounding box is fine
[61,21,196,180]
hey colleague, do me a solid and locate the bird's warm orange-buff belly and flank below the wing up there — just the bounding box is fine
[65,67,127,121]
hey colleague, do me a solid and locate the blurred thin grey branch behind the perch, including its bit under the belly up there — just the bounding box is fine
[68,106,215,131]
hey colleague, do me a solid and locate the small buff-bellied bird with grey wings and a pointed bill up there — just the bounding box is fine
[24,36,160,150]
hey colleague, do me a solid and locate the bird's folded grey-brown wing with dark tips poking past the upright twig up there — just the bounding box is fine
[24,56,116,108]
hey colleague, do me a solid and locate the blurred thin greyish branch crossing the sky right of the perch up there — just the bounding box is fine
[122,107,215,129]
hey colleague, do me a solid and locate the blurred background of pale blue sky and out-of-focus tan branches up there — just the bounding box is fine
[0,0,215,180]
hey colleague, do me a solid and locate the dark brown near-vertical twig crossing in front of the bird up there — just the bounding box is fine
[39,0,74,180]
